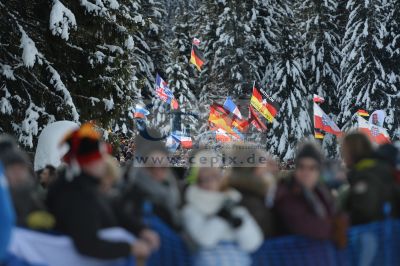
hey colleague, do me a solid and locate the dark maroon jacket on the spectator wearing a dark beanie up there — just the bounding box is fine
[274,177,335,239]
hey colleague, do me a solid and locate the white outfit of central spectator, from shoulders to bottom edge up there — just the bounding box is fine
[182,186,263,266]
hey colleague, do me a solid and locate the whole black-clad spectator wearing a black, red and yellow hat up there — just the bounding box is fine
[47,124,151,259]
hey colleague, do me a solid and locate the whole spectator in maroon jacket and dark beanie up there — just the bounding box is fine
[274,144,346,246]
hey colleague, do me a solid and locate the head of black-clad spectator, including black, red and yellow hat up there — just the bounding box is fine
[63,123,109,178]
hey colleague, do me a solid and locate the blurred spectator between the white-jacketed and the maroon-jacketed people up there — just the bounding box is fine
[227,143,277,238]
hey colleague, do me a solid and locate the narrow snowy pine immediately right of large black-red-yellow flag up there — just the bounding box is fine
[267,1,312,160]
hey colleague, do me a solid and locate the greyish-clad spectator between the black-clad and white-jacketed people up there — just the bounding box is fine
[121,136,181,230]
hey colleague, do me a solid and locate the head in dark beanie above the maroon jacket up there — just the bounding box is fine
[294,143,323,189]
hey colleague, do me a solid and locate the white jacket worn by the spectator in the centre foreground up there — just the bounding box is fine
[182,186,263,252]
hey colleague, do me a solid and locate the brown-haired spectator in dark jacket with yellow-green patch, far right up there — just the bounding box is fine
[342,133,399,224]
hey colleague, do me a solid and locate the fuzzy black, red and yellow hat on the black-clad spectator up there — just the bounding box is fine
[61,123,109,165]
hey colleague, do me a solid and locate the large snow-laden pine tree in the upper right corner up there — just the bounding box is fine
[339,0,400,135]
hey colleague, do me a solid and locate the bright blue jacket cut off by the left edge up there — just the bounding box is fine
[0,164,15,262]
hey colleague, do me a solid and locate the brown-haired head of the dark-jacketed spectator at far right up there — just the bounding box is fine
[341,132,374,168]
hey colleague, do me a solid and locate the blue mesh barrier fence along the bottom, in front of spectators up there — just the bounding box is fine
[147,217,400,266]
